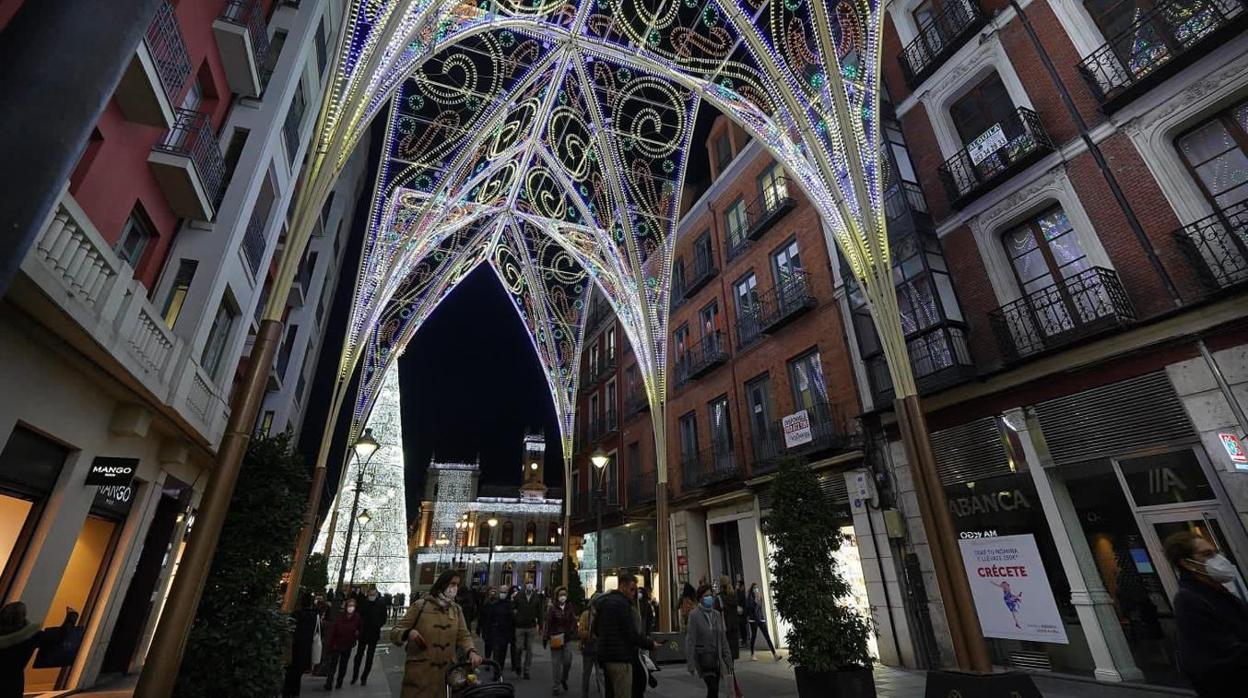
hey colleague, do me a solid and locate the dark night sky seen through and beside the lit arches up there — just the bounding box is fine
[298,103,715,517]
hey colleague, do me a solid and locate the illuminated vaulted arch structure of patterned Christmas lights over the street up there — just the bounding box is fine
[285,0,915,616]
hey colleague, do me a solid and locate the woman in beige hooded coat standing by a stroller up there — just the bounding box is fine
[391,569,482,698]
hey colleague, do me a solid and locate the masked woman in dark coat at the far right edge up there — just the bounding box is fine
[1164,531,1248,698]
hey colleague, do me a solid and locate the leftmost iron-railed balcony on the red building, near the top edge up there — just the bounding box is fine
[112,1,191,129]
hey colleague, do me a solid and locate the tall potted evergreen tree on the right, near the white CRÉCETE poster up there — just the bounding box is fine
[763,461,875,698]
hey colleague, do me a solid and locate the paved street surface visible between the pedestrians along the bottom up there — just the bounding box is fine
[287,641,1191,698]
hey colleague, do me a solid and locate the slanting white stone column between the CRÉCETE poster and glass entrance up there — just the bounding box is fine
[1002,408,1144,682]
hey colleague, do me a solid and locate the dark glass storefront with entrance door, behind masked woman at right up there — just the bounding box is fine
[1060,448,1246,686]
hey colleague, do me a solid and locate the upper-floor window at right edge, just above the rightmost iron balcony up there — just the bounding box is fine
[1174,102,1248,211]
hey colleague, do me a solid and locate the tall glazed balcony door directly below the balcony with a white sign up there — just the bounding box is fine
[1001,206,1107,337]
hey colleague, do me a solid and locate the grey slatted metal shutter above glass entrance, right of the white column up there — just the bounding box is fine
[1036,371,1198,465]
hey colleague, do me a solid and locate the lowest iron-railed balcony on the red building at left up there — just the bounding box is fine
[147,109,226,221]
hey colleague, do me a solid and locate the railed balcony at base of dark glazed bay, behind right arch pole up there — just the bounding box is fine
[866,321,975,407]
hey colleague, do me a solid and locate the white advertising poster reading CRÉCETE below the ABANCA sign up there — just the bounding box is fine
[958,534,1068,644]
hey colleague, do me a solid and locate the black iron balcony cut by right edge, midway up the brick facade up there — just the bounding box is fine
[1174,201,1248,291]
